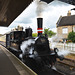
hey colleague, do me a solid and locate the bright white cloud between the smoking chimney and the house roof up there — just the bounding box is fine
[43,1,75,29]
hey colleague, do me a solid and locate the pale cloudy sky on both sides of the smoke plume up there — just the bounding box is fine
[0,0,75,34]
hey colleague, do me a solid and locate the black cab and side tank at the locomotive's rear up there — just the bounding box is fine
[6,31,25,57]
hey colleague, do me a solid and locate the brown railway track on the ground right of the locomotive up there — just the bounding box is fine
[55,58,75,75]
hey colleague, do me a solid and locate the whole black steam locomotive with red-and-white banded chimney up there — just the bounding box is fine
[6,18,63,73]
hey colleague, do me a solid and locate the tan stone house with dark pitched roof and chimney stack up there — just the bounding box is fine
[56,11,75,40]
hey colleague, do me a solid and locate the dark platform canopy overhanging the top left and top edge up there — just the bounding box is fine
[0,0,75,27]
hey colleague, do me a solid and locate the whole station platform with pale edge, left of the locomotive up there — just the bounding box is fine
[0,45,37,75]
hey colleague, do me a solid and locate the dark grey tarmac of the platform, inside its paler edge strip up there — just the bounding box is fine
[0,46,20,75]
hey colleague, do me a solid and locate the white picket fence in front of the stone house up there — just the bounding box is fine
[50,42,75,54]
